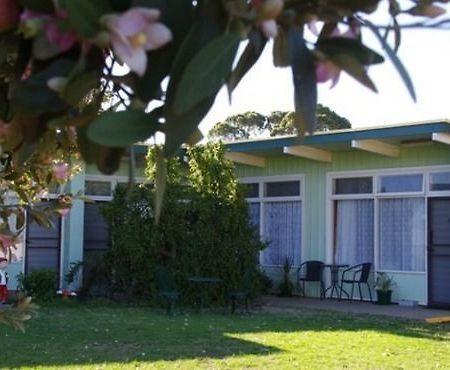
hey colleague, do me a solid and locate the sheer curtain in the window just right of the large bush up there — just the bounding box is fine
[262,201,301,266]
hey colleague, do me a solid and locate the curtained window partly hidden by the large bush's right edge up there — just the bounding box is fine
[246,180,302,266]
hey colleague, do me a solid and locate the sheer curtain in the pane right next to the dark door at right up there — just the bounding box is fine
[380,198,426,271]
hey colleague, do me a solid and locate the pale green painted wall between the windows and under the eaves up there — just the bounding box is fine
[236,143,450,303]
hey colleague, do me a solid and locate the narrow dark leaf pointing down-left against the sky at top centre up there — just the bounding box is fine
[227,30,267,100]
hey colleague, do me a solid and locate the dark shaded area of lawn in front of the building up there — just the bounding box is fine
[0,305,449,368]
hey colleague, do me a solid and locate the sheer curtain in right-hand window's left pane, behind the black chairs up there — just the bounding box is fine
[335,199,374,265]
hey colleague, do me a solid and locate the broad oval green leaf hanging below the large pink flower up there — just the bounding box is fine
[87,110,160,147]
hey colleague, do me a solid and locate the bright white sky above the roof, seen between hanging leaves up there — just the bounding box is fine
[200,5,450,134]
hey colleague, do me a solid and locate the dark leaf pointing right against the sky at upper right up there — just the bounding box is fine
[316,37,384,65]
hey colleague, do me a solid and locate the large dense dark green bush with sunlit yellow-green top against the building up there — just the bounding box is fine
[98,144,264,301]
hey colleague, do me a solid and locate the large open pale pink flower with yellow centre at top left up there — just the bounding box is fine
[103,7,172,77]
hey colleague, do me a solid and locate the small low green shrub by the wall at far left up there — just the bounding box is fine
[17,269,58,301]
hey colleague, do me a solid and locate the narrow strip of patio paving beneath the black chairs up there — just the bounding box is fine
[254,295,450,320]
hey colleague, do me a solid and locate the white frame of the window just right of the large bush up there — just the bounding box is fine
[238,175,305,268]
